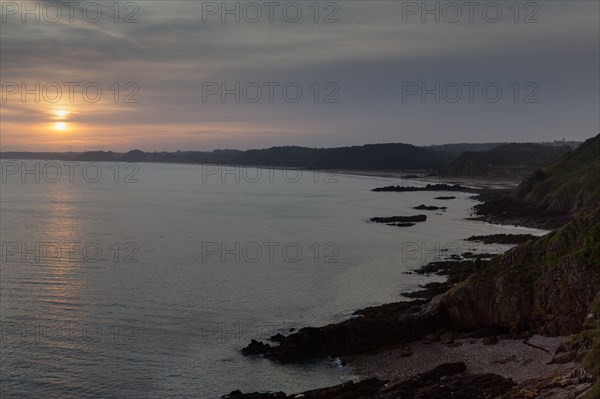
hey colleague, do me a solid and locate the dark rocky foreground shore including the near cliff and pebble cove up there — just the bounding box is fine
[234,212,600,399]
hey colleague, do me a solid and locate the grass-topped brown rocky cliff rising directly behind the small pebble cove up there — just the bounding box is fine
[442,211,600,335]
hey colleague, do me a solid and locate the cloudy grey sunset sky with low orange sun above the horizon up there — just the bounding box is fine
[0,0,600,151]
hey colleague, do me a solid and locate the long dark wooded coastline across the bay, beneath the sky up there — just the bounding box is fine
[0,142,578,188]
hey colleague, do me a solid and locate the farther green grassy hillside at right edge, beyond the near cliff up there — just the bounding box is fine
[515,135,600,213]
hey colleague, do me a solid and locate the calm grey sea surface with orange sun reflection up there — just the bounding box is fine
[0,161,544,398]
